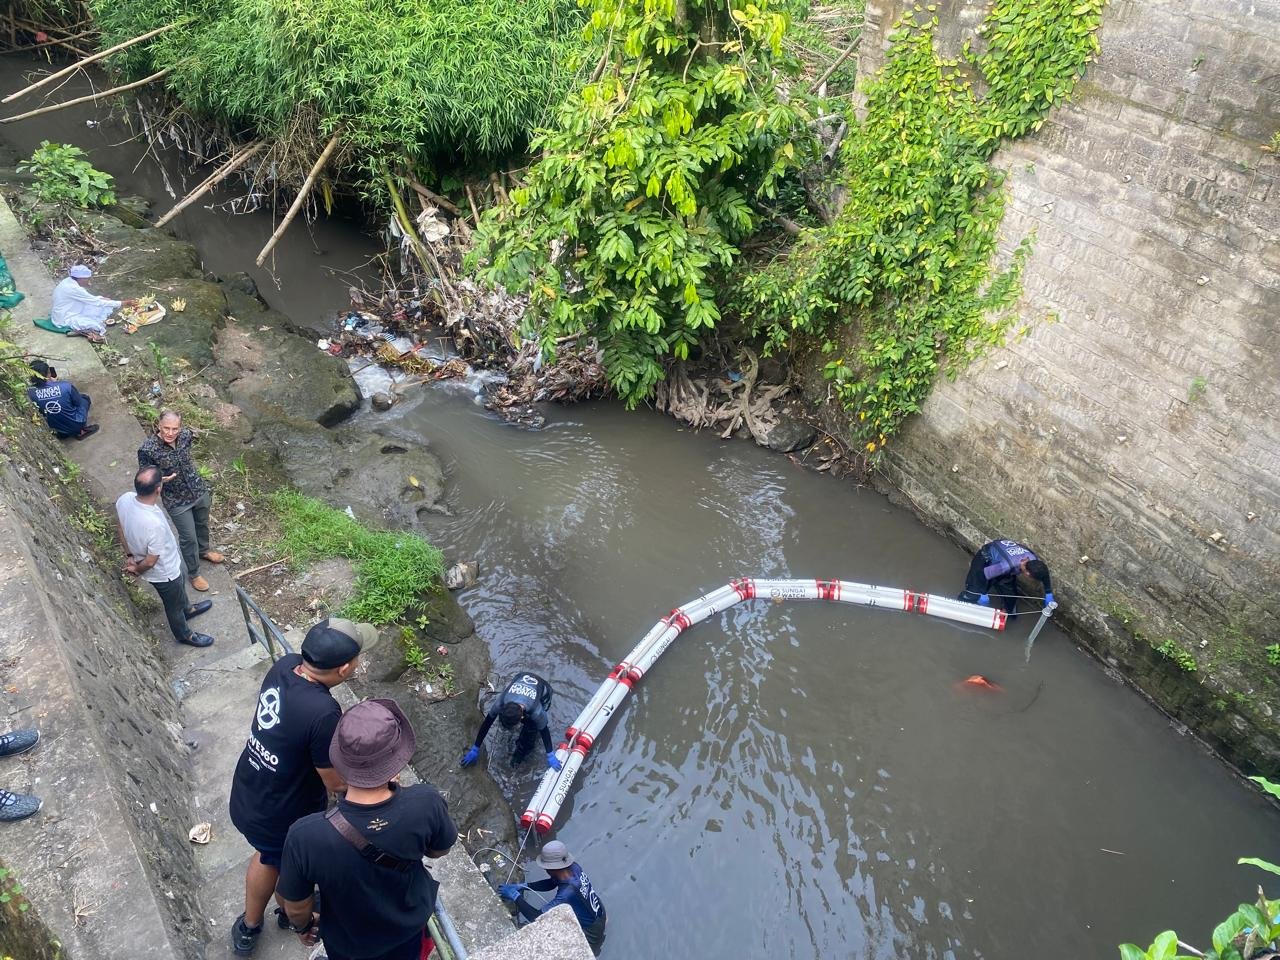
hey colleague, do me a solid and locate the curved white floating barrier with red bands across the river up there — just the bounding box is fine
[520,579,1007,833]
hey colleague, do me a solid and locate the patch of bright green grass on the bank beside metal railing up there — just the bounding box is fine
[271,490,444,623]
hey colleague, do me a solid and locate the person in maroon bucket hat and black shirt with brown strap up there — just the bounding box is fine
[275,700,458,960]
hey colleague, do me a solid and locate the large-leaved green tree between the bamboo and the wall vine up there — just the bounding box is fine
[476,0,808,406]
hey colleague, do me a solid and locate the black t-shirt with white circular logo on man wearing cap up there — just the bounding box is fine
[230,653,342,847]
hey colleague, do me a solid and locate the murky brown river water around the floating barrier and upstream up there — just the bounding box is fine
[0,54,1280,960]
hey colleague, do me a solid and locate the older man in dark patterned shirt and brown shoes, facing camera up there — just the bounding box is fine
[138,410,223,591]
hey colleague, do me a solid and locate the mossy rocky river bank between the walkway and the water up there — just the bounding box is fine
[0,146,524,855]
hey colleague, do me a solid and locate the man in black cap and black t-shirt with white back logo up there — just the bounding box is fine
[230,618,378,956]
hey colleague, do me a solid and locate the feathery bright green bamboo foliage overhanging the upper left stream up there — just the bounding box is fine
[92,0,582,168]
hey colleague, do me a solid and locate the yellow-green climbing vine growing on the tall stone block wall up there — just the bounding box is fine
[740,0,1103,453]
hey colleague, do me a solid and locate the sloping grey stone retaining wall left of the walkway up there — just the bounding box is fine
[0,409,207,960]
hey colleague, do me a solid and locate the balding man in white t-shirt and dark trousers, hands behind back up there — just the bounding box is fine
[115,467,214,646]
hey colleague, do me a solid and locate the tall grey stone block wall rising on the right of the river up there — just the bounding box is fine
[844,0,1280,773]
